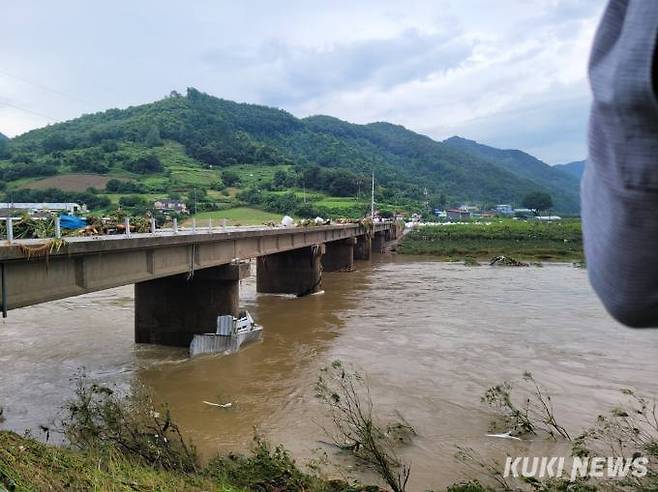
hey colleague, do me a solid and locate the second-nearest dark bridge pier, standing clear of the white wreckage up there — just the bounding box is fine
[256,244,325,296]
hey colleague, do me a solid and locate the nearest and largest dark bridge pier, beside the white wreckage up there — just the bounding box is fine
[135,263,249,347]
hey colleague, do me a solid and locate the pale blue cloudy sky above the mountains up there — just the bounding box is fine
[0,0,605,163]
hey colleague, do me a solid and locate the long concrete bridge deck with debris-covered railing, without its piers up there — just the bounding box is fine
[0,223,392,309]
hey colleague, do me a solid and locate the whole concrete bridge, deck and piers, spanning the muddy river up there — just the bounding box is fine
[0,223,401,346]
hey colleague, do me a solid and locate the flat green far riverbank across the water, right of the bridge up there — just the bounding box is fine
[398,219,584,261]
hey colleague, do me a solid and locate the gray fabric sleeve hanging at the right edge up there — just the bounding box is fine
[581,0,658,327]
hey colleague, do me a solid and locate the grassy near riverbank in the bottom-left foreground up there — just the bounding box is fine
[0,431,381,492]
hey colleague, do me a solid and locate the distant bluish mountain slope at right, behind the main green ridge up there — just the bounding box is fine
[444,137,579,210]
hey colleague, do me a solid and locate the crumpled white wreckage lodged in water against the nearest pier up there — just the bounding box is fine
[190,311,263,357]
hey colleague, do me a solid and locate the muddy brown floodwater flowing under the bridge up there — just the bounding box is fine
[0,256,658,490]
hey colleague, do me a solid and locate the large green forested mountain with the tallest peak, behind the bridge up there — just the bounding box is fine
[0,89,578,212]
